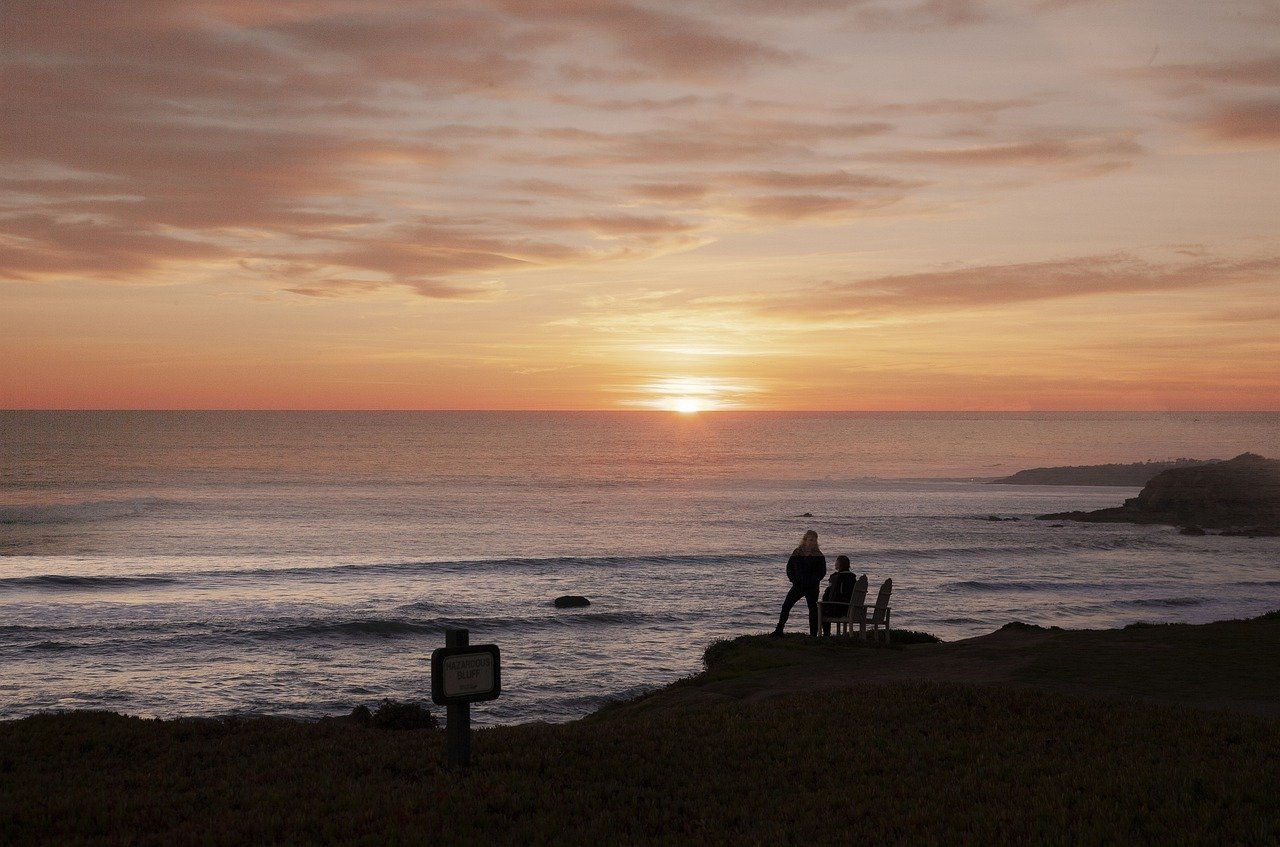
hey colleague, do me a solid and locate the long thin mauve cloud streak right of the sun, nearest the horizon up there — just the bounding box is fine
[756,255,1280,316]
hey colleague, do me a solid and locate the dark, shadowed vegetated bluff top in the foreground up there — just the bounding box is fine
[0,613,1280,844]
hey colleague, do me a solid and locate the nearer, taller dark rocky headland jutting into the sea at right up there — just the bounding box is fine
[1039,453,1280,535]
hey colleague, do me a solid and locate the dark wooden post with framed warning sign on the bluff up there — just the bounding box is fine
[431,627,502,770]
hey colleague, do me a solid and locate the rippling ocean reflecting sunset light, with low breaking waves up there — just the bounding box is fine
[0,411,1280,725]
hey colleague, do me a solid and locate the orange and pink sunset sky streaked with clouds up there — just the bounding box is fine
[0,0,1280,411]
